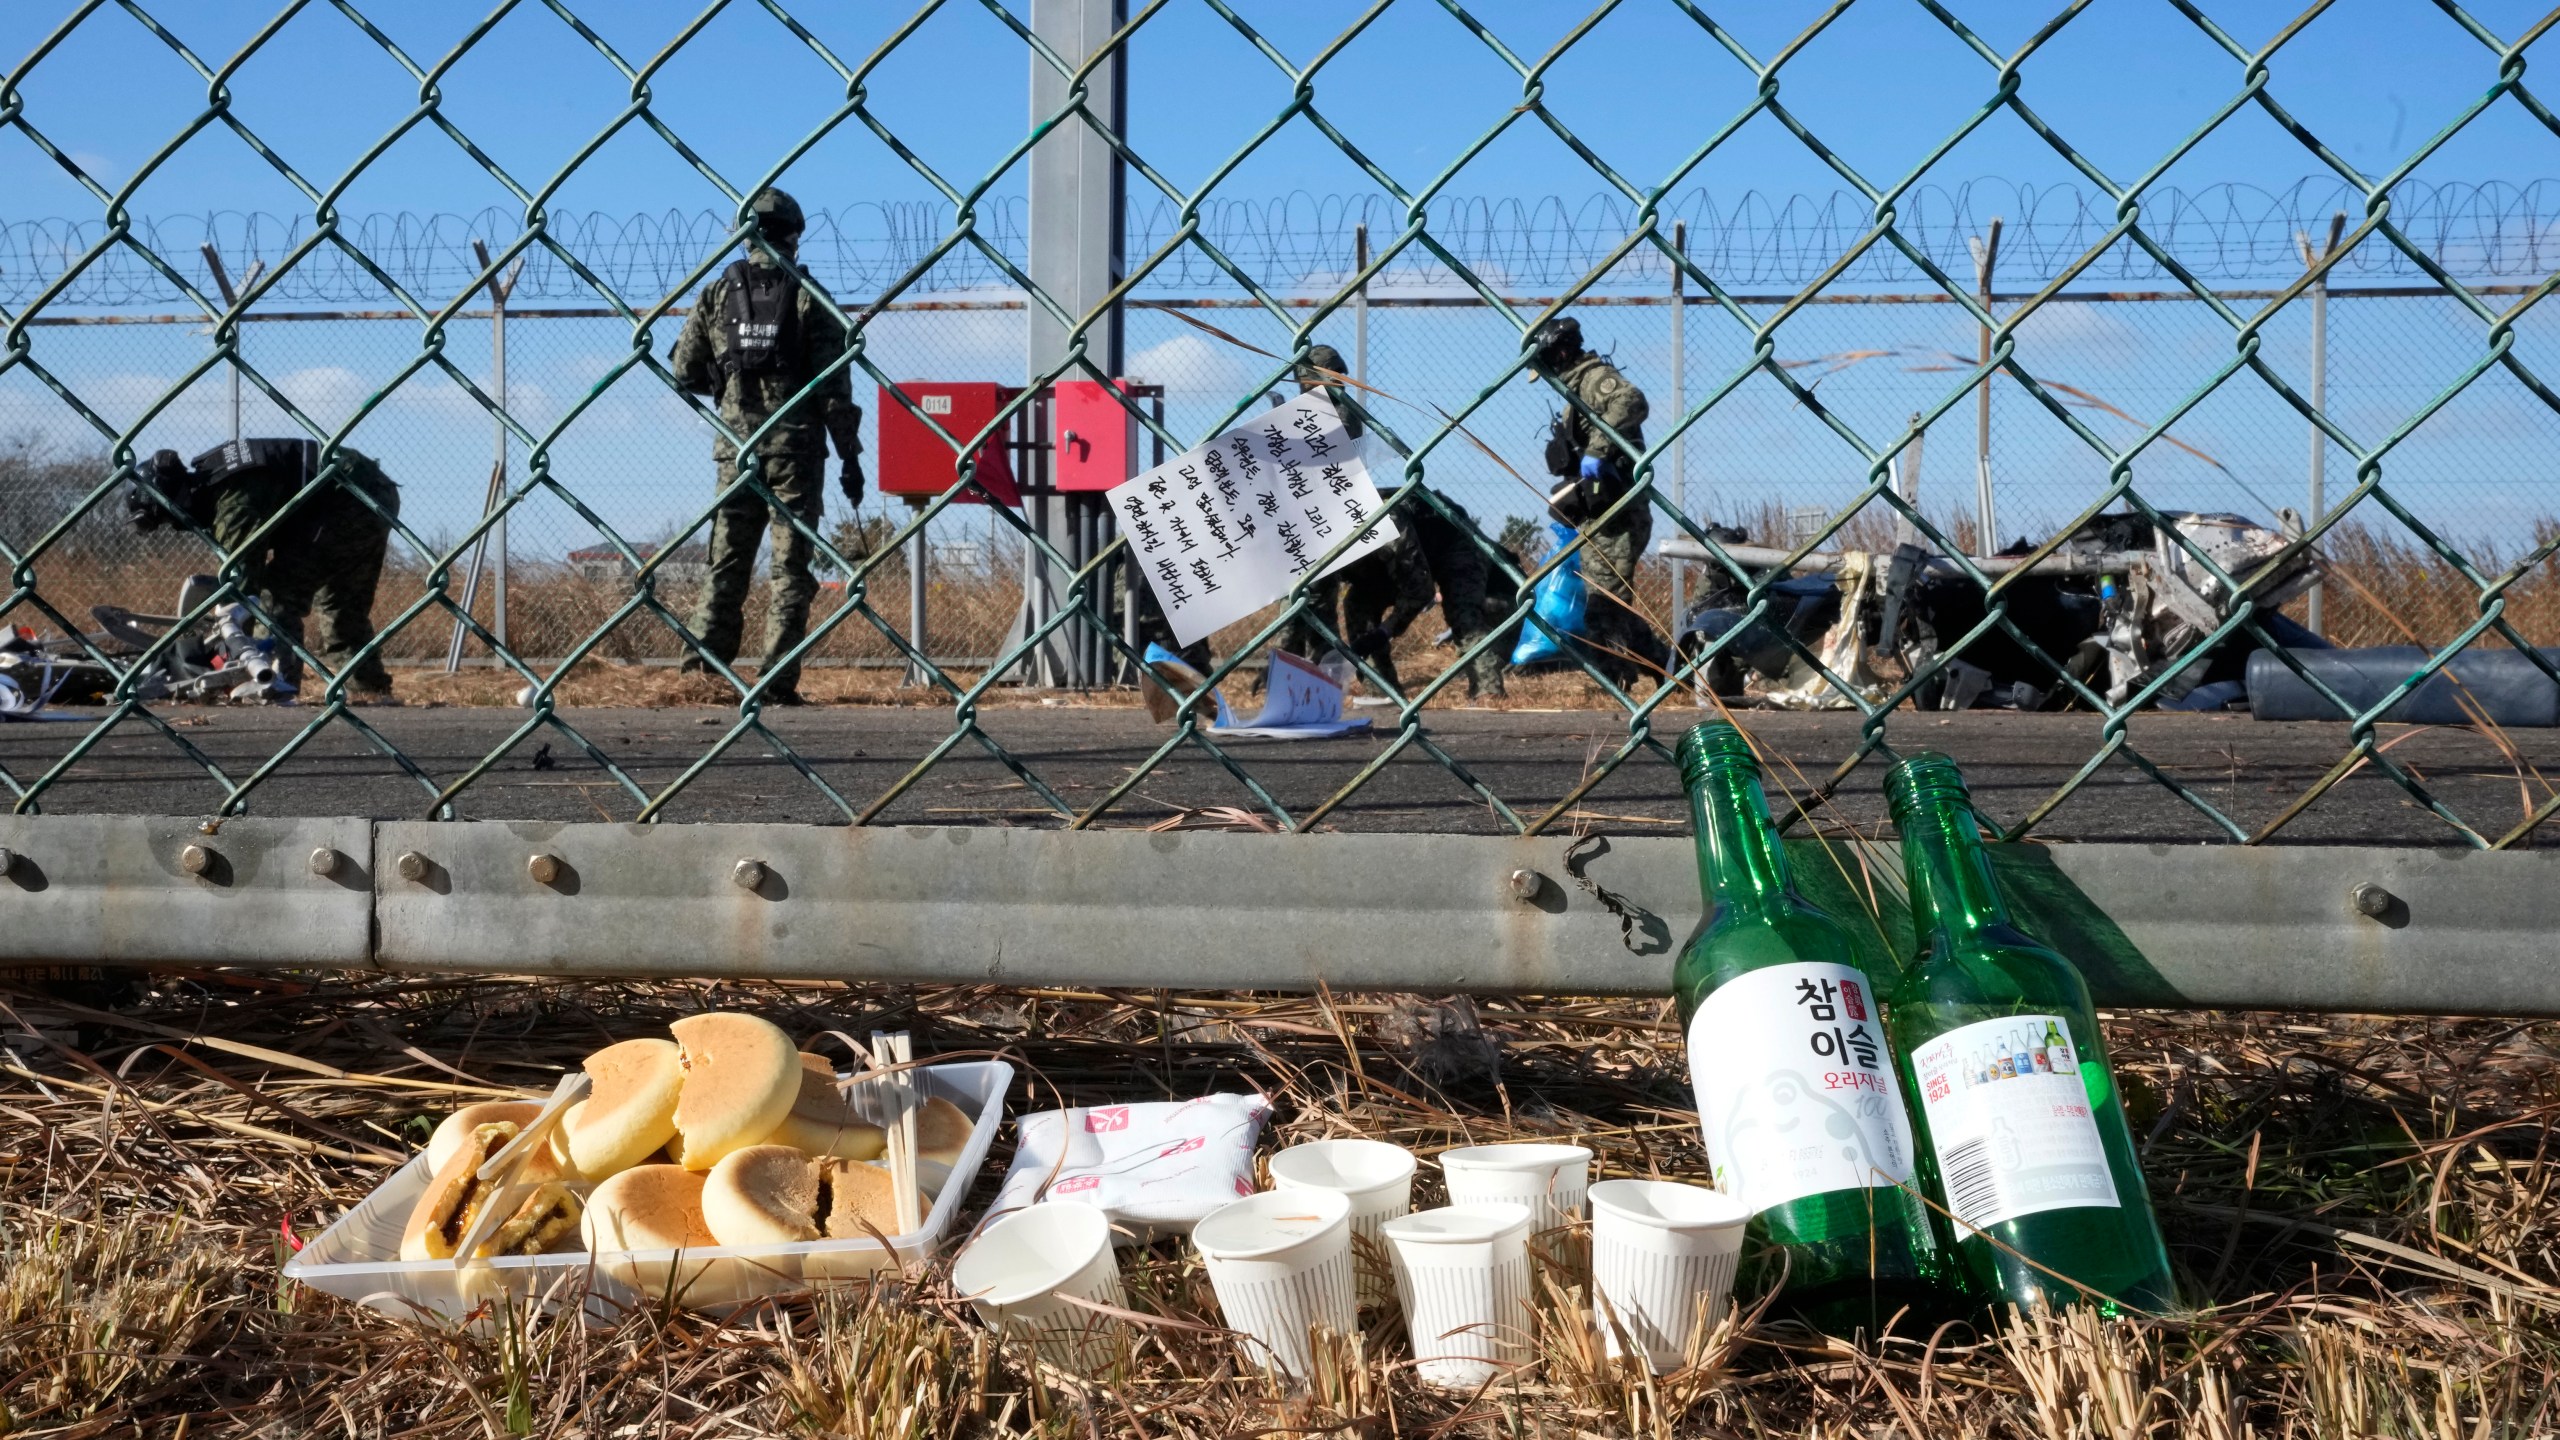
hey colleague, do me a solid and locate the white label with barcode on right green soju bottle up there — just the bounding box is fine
[1912,1015,2117,1238]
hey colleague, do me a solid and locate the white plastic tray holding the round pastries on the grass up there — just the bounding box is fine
[284,1061,1014,1320]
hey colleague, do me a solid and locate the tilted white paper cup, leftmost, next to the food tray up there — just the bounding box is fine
[952,1199,1129,1376]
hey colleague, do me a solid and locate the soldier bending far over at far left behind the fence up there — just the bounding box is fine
[125,438,399,697]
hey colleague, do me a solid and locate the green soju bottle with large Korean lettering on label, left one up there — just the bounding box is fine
[1672,723,1951,1332]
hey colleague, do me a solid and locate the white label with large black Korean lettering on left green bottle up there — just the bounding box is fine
[1690,961,1912,1212]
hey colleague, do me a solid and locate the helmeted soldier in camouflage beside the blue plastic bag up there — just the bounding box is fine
[1528,315,1669,687]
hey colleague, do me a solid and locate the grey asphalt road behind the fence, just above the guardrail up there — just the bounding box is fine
[0,705,2560,846]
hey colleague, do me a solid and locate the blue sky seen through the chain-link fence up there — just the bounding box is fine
[0,0,2560,566]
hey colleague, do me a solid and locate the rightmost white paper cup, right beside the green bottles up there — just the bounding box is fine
[1590,1181,1751,1373]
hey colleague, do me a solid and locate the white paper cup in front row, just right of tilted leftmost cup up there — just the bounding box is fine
[1190,1189,1359,1381]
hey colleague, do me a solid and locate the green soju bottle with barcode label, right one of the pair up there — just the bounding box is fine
[1884,753,2173,1312]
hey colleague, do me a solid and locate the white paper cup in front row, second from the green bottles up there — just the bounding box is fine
[1385,1199,1531,1389]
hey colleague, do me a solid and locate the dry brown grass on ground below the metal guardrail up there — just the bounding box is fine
[0,974,2560,1440]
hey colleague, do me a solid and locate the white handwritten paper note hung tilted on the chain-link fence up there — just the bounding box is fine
[1111,389,1395,646]
